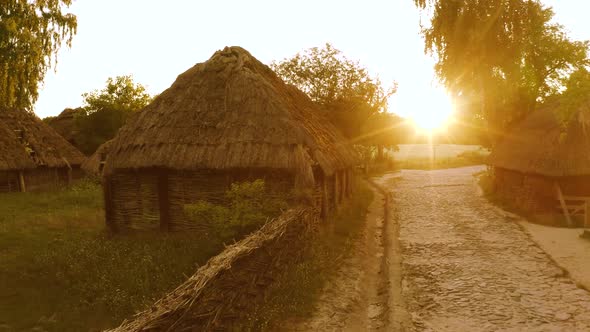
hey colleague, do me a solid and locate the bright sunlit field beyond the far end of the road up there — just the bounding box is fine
[390,144,489,169]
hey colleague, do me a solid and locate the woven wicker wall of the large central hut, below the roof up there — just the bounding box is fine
[105,170,294,230]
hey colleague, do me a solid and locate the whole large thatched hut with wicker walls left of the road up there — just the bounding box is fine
[104,47,356,230]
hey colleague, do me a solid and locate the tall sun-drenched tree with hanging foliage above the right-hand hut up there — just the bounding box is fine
[414,0,588,141]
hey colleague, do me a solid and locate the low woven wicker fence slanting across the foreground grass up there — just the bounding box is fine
[111,209,317,332]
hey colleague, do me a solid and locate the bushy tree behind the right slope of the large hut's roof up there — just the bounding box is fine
[271,44,396,139]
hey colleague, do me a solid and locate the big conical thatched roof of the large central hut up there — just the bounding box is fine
[105,47,355,178]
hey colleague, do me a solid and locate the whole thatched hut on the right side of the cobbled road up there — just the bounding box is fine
[489,105,590,224]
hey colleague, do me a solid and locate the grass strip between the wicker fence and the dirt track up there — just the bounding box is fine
[244,183,373,331]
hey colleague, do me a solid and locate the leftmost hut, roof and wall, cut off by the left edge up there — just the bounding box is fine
[0,122,35,192]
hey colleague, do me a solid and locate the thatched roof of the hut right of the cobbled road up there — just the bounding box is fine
[489,105,590,177]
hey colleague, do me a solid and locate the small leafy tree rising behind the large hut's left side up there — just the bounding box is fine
[75,76,153,154]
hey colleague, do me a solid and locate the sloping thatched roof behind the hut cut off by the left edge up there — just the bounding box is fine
[0,108,86,167]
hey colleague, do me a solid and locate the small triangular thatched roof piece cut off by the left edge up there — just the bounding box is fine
[0,122,35,171]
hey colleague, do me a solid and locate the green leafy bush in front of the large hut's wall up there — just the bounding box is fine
[184,179,288,241]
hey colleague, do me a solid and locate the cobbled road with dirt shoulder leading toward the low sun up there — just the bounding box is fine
[295,166,590,332]
